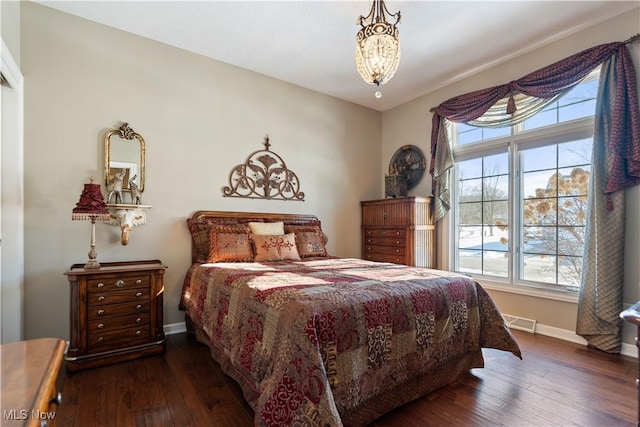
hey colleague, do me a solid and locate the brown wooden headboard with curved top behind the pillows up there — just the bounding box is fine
[189,211,328,262]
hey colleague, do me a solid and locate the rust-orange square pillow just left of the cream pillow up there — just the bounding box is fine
[207,225,253,262]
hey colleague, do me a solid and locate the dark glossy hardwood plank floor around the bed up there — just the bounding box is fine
[56,331,638,427]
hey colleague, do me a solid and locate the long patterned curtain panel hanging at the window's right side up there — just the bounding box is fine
[576,49,640,353]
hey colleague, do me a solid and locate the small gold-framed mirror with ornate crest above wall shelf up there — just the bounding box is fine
[104,123,145,204]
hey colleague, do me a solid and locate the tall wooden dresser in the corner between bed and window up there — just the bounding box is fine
[360,197,436,268]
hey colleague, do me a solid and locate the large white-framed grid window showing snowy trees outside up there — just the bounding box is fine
[453,73,598,291]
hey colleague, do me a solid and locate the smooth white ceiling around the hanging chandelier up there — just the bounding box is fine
[37,0,639,111]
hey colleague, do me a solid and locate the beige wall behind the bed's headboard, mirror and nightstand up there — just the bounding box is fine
[21,2,381,338]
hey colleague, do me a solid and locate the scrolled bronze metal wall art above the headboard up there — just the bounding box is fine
[222,135,304,201]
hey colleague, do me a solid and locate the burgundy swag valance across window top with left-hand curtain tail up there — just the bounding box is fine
[429,39,632,220]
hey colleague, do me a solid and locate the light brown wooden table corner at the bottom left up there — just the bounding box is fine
[0,338,66,427]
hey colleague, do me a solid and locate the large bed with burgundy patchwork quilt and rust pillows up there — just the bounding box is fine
[180,211,521,426]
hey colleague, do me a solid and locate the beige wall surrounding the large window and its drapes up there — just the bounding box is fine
[381,9,640,344]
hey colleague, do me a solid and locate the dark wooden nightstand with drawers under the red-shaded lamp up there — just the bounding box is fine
[64,260,166,372]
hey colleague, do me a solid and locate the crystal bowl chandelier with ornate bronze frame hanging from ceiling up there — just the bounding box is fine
[355,0,400,86]
